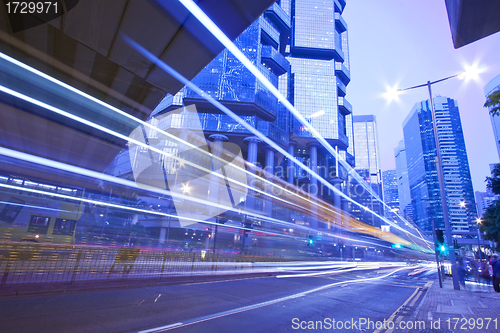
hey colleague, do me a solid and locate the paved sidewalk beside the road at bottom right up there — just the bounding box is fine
[395,277,500,333]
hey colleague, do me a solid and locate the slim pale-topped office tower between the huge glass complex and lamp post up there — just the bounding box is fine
[349,115,384,226]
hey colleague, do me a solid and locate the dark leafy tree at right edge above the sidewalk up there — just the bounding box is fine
[481,162,500,251]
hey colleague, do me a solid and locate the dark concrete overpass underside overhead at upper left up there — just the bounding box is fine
[0,0,275,187]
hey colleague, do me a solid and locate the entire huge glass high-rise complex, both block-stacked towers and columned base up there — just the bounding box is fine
[114,0,354,232]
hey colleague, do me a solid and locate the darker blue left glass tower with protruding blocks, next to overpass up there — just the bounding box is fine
[112,3,290,179]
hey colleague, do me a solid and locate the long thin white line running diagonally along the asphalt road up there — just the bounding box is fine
[138,267,410,333]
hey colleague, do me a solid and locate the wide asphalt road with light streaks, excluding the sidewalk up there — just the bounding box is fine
[0,268,436,333]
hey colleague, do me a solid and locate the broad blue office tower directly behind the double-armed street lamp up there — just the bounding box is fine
[403,96,477,231]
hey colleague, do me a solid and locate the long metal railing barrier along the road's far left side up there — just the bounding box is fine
[0,243,327,286]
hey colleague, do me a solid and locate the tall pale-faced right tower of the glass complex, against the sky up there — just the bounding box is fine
[281,0,354,200]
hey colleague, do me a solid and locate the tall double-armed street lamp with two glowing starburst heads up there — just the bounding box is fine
[385,68,477,290]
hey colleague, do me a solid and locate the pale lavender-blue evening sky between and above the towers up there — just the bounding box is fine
[343,0,500,191]
